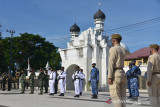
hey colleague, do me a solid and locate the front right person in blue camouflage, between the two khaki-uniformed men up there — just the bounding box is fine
[130,60,141,101]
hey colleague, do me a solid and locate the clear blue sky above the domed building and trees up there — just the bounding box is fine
[0,0,160,52]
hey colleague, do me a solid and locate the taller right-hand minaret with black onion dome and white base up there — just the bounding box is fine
[93,9,106,34]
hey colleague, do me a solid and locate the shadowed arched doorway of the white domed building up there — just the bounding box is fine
[66,64,77,90]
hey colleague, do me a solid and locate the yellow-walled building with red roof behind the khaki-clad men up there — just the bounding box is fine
[124,47,160,75]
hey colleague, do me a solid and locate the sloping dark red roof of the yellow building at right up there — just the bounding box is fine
[125,47,160,60]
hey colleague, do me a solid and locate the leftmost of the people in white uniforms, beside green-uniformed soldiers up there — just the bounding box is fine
[49,69,56,95]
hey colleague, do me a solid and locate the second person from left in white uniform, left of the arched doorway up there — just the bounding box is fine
[58,67,66,96]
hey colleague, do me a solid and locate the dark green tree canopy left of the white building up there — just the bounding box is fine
[0,33,61,72]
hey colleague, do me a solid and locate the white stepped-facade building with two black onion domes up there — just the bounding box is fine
[59,9,109,91]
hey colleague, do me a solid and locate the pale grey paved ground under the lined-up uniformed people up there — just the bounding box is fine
[0,90,150,107]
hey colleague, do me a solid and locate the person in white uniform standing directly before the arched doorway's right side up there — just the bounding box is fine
[72,66,81,97]
